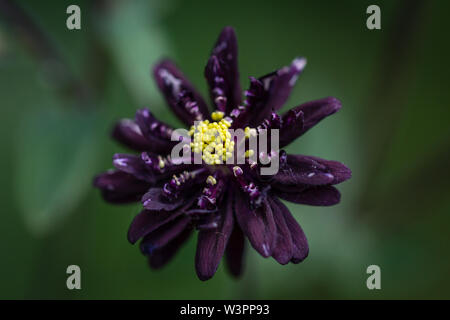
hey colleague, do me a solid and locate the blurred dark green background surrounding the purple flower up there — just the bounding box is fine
[0,0,450,299]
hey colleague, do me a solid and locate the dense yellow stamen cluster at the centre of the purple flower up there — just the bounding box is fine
[189,111,234,165]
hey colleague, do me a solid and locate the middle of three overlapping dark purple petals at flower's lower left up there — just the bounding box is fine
[140,216,191,254]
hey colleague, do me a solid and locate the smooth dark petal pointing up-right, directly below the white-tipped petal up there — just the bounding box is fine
[280,97,342,144]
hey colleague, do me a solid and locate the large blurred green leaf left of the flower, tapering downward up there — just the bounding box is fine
[14,107,99,235]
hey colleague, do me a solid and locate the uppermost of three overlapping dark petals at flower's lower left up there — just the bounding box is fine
[128,206,183,244]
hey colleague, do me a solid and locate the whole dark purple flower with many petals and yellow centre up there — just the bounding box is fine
[94,27,351,280]
